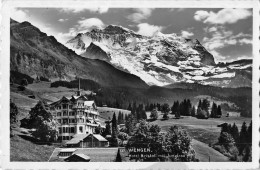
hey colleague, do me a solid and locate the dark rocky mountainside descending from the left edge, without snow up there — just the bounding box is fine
[10,20,147,88]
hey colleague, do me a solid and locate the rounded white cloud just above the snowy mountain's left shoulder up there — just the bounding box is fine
[78,18,104,31]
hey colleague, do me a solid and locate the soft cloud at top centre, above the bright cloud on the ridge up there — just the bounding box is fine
[127,8,153,23]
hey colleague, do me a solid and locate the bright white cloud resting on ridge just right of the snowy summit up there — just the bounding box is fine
[137,23,163,36]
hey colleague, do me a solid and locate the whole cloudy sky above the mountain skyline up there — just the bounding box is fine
[11,8,253,62]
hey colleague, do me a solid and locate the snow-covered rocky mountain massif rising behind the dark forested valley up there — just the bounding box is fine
[65,25,252,87]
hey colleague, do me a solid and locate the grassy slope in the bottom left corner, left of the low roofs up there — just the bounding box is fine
[10,136,55,162]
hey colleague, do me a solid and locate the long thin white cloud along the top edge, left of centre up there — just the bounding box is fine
[60,7,109,14]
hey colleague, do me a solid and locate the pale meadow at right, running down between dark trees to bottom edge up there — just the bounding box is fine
[152,115,251,162]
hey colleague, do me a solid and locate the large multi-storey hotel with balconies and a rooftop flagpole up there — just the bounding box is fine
[49,83,101,142]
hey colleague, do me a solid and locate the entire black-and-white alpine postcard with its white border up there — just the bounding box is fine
[2,0,259,169]
